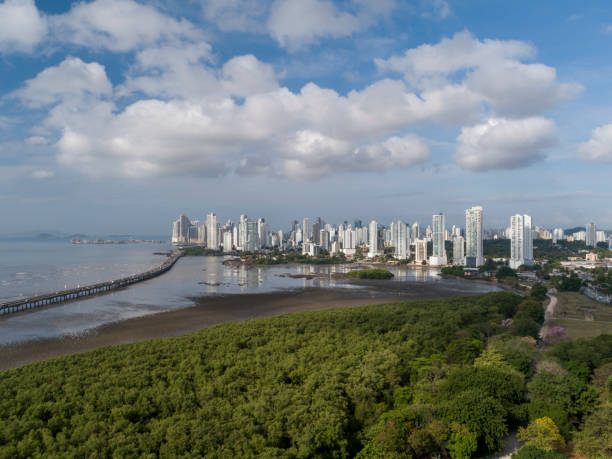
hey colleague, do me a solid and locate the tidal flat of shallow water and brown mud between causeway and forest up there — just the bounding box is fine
[0,245,499,368]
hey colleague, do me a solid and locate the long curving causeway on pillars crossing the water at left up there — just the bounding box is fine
[0,250,183,315]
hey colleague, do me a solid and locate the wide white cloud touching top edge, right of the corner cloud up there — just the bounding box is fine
[49,0,203,52]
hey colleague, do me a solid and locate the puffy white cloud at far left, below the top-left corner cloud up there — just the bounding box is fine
[12,57,112,108]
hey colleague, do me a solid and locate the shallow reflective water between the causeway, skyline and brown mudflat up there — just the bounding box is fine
[0,255,497,344]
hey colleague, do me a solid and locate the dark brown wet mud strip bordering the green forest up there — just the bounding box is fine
[0,281,502,370]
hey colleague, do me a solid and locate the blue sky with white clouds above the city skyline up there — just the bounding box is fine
[0,0,612,234]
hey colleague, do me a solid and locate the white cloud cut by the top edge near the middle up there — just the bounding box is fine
[268,0,395,50]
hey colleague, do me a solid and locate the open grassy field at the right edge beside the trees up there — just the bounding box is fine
[553,292,612,339]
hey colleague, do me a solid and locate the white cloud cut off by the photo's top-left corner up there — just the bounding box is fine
[0,0,47,53]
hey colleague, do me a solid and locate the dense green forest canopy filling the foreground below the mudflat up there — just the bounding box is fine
[0,292,612,458]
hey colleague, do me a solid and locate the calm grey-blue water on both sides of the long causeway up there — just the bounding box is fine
[0,242,497,345]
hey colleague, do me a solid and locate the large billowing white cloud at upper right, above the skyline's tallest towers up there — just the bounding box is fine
[375,31,582,117]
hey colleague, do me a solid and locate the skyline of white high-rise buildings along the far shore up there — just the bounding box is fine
[172,210,605,269]
